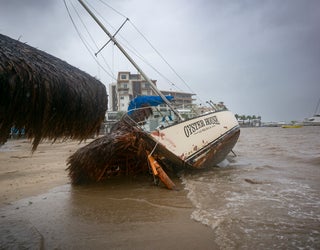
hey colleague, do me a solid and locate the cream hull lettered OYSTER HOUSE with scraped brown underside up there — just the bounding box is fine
[142,110,240,168]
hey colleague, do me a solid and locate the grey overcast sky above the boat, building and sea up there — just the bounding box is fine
[0,0,320,121]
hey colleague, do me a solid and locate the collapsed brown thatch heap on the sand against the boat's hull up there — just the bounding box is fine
[67,106,152,184]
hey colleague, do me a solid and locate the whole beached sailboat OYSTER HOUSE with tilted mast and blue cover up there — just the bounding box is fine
[69,0,240,188]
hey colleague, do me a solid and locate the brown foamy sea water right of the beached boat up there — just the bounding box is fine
[183,127,320,249]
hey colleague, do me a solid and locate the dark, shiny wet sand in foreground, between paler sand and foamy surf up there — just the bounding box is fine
[0,179,218,249]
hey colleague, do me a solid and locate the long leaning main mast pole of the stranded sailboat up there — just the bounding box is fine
[78,0,183,120]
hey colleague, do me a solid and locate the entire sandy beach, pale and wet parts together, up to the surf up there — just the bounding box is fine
[0,140,216,249]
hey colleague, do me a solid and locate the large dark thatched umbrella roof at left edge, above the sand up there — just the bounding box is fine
[0,34,107,150]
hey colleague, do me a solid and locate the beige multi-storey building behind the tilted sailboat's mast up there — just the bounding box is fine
[109,71,194,111]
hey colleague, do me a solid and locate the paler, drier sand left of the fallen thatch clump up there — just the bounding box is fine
[0,139,89,206]
